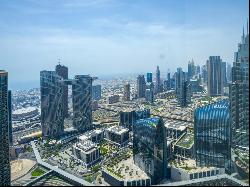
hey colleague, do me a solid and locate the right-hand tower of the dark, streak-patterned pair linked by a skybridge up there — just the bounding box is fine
[72,75,92,132]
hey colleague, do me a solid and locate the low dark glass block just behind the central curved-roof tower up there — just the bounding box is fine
[120,109,150,130]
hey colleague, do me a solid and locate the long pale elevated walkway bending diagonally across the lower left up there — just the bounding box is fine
[31,141,95,186]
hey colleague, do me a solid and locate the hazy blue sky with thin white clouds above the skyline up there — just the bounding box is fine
[0,0,249,88]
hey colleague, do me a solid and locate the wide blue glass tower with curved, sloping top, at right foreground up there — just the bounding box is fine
[194,100,231,173]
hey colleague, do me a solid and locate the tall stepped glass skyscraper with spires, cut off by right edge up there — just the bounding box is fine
[229,24,249,149]
